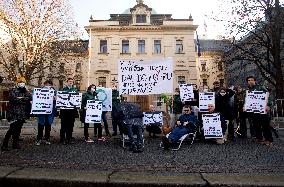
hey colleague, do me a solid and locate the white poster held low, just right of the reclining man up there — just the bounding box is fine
[202,113,223,139]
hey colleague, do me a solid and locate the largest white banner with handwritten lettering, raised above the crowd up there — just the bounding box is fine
[118,58,173,95]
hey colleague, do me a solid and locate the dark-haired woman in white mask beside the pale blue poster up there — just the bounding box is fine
[81,84,105,143]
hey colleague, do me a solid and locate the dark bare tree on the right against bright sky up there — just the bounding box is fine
[215,0,284,98]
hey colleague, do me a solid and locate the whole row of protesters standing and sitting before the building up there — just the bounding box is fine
[1,76,273,152]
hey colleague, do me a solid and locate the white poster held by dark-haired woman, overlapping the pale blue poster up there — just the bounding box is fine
[85,100,103,123]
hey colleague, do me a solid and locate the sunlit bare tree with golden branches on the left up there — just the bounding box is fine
[0,0,78,82]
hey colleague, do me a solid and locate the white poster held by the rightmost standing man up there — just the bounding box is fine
[245,90,269,114]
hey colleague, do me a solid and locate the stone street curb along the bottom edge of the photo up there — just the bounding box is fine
[0,166,284,187]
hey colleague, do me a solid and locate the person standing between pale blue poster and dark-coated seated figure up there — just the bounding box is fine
[111,86,121,136]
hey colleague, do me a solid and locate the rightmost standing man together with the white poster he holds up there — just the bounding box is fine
[245,76,273,145]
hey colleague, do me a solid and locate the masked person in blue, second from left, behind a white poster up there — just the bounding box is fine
[35,80,56,146]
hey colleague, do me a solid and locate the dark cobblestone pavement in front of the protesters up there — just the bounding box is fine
[0,119,284,175]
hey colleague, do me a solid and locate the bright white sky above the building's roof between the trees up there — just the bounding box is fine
[70,0,222,38]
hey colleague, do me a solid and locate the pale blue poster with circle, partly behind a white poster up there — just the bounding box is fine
[96,87,112,111]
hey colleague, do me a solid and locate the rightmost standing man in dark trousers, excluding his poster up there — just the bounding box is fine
[246,76,273,145]
